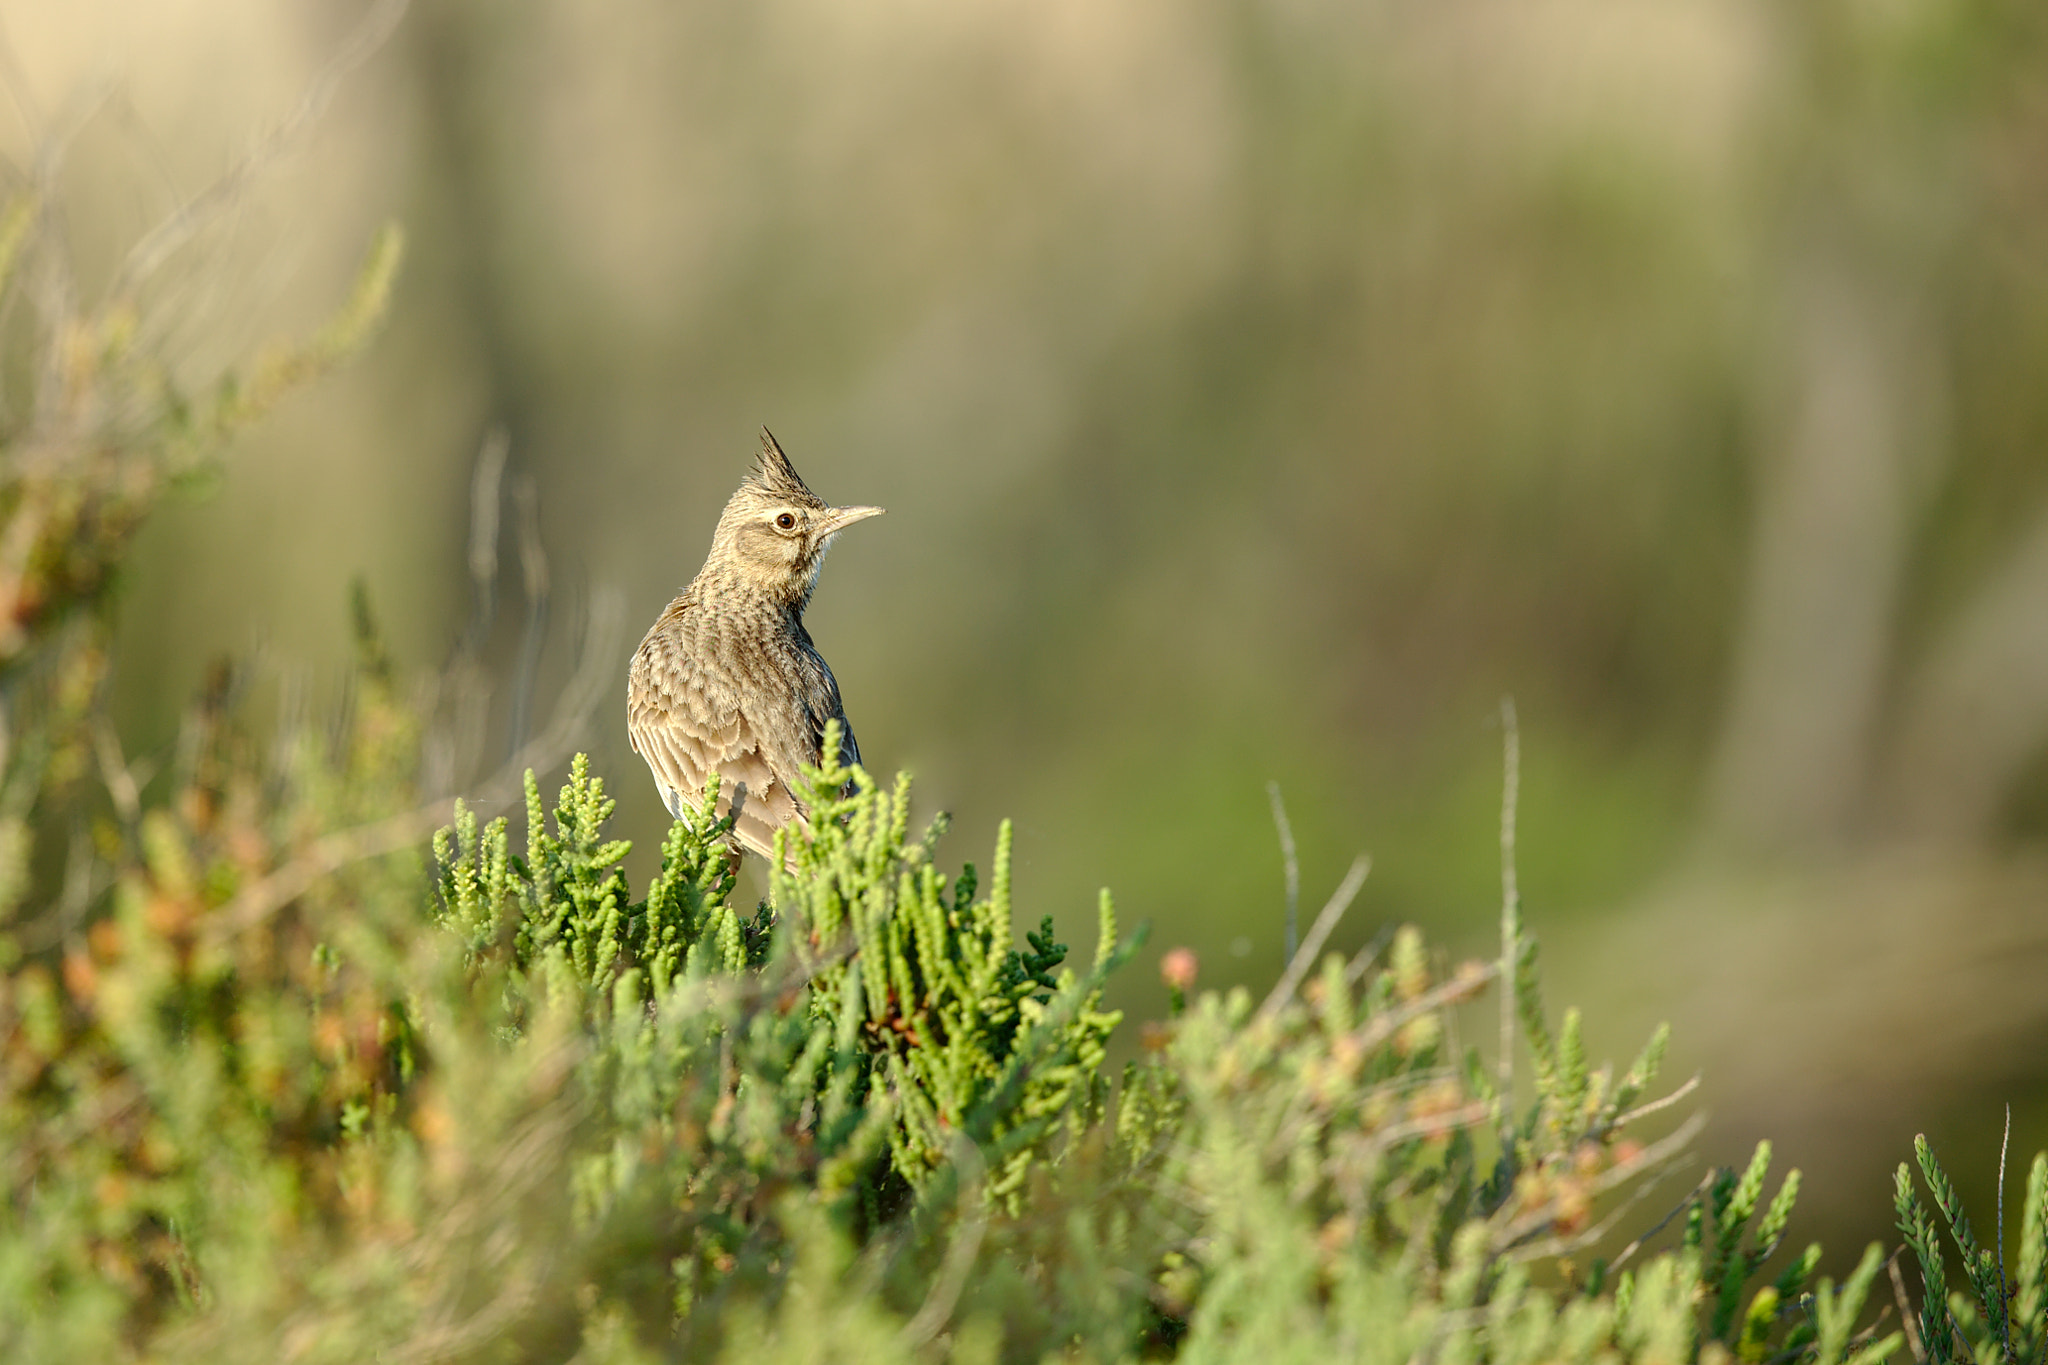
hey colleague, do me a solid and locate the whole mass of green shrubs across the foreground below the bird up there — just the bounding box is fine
[0,179,1894,1365]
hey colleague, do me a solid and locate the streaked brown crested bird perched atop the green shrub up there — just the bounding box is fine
[627,428,883,866]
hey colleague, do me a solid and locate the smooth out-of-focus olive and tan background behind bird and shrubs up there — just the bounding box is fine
[16,0,2048,1263]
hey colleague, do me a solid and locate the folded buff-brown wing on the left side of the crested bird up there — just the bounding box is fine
[627,636,805,857]
